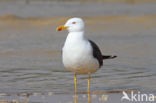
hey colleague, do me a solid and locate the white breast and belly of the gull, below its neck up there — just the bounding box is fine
[62,39,99,74]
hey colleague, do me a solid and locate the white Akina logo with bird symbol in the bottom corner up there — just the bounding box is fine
[121,91,155,102]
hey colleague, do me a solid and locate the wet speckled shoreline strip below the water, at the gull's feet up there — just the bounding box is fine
[0,91,156,103]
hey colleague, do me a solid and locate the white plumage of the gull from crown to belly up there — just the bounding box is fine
[62,18,99,74]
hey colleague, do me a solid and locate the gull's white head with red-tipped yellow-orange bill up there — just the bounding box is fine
[56,18,85,32]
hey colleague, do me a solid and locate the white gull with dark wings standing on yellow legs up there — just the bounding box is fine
[56,17,117,94]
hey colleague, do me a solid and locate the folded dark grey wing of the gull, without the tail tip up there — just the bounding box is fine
[88,40,103,67]
